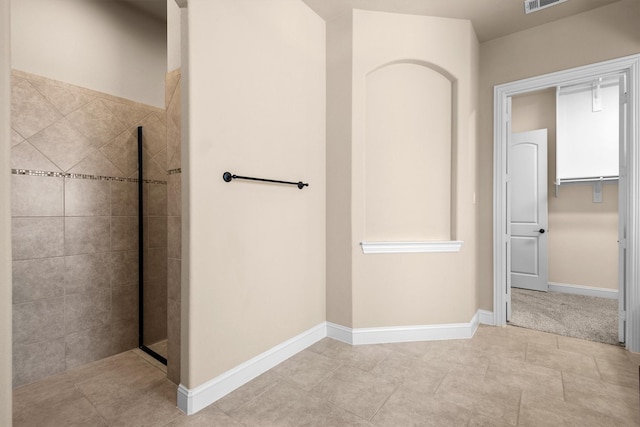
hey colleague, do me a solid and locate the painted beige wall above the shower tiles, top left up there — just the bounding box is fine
[11,0,167,108]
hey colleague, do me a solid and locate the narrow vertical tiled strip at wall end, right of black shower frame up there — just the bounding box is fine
[165,70,182,384]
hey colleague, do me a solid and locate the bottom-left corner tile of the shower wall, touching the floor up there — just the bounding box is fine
[13,338,66,387]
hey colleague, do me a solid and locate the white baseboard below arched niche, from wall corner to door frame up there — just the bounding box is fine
[327,310,488,345]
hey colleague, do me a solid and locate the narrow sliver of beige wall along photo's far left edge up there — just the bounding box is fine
[0,0,12,426]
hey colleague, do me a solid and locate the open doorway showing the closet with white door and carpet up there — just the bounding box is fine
[507,88,620,345]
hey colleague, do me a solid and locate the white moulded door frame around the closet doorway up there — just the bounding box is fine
[493,55,640,352]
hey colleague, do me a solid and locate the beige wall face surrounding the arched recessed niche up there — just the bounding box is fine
[348,10,478,328]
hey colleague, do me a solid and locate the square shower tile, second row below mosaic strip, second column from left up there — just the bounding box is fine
[64,216,111,255]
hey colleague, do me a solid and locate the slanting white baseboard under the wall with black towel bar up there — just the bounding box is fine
[178,322,327,415]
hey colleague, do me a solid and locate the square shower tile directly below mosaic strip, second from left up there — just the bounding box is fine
[64,178,111,216]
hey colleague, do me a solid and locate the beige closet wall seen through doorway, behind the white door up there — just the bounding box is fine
[511,90,618,289]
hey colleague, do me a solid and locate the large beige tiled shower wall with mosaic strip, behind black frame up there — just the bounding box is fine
[11,71,168,386]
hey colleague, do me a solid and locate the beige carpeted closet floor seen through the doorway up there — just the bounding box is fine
[509,288,618,344]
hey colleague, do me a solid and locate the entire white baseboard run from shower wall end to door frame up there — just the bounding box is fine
[178,310,494,415]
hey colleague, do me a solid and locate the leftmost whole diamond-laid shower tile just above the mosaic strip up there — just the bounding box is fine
[29,119,95,171]
